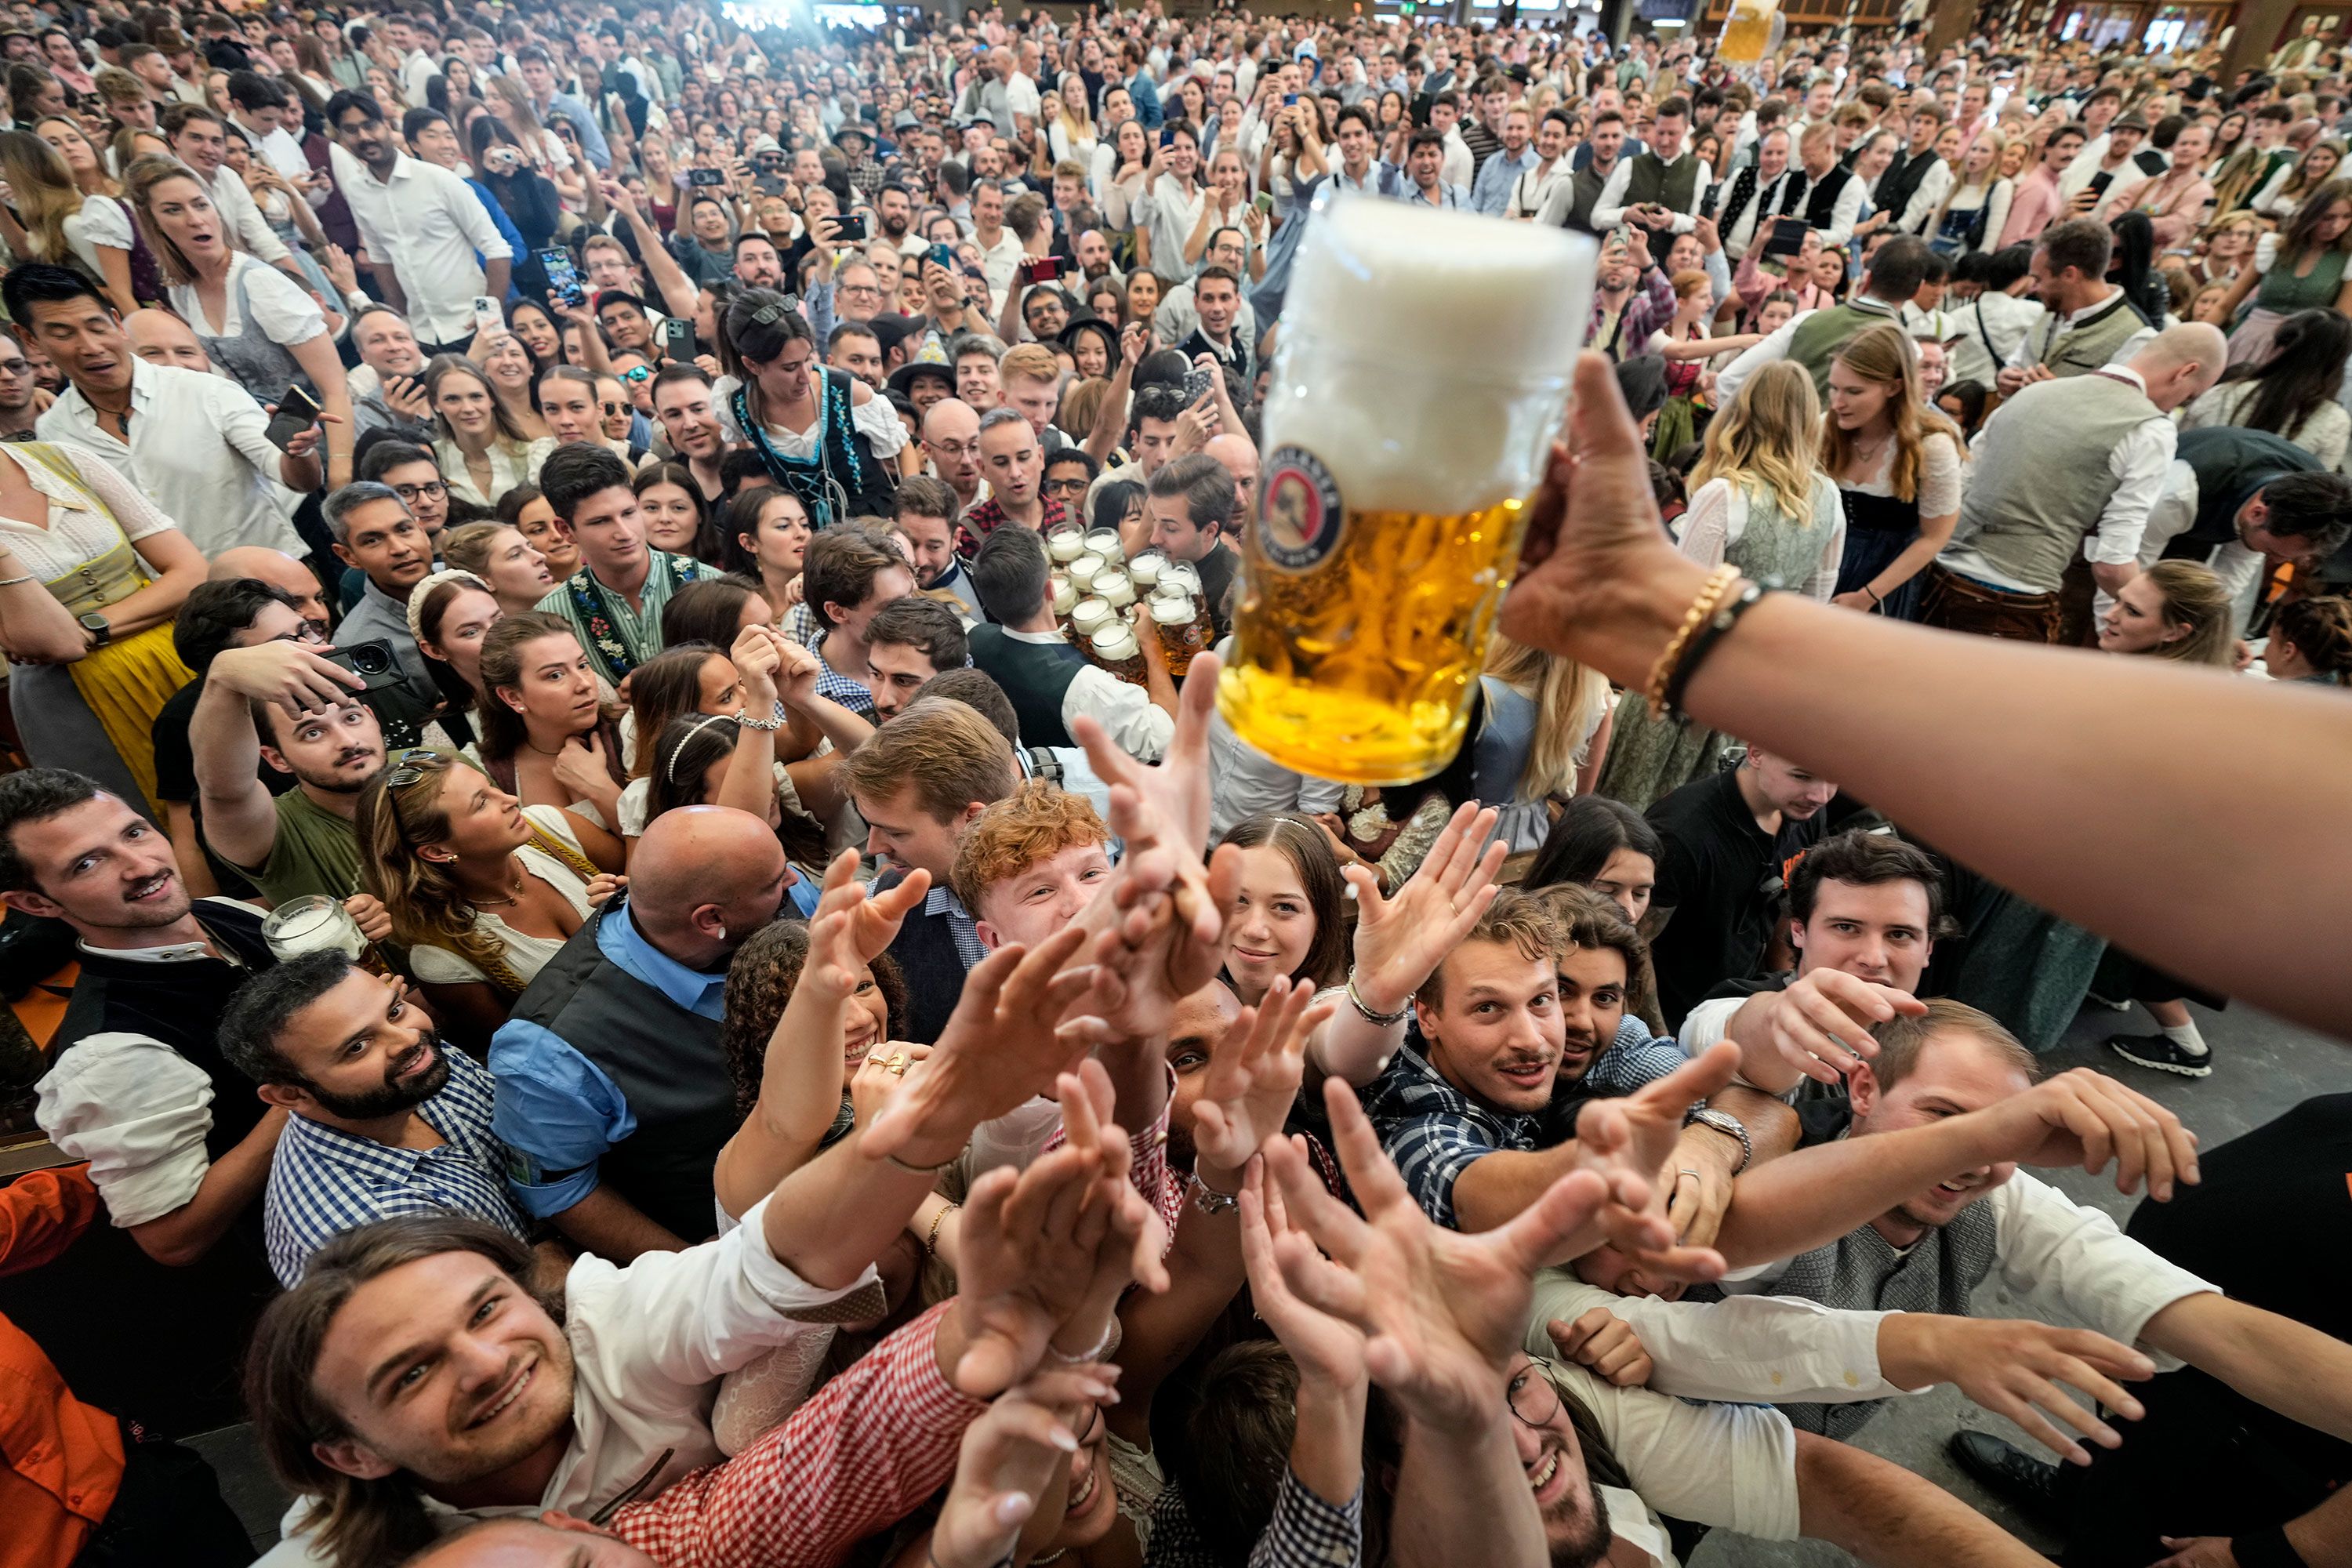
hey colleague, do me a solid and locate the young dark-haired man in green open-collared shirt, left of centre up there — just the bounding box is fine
[539,442,717,684]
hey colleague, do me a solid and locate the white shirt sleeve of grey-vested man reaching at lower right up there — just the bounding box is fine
[1722,1171,2218,1373]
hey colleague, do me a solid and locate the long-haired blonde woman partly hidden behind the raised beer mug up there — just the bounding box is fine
[1470,633,1609,853]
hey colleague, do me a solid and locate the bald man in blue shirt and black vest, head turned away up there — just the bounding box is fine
[489,806,793,1262]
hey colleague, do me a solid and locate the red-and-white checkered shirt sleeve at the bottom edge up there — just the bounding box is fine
[612,1300,988,1568]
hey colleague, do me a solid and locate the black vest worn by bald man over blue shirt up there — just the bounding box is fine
[513,898,743,1241]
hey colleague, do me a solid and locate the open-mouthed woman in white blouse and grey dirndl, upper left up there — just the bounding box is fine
[122,158,358,487]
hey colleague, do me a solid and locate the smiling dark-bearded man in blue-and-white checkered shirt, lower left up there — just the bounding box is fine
[221,952,527,1288]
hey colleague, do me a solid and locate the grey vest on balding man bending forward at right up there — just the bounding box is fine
[1955,371,2159,593]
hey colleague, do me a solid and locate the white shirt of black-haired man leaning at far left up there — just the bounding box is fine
[33,358,303,557]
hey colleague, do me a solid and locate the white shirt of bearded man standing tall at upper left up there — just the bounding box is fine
[329,148,515,343]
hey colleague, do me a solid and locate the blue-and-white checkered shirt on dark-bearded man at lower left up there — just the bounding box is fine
[261,1041,524,1290]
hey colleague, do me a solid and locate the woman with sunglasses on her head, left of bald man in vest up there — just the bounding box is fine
[358,750,609,1048]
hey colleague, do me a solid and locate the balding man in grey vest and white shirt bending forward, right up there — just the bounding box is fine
[1919,322,2227,644]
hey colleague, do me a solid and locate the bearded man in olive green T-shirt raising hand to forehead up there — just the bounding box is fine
[188,640,388,907]
